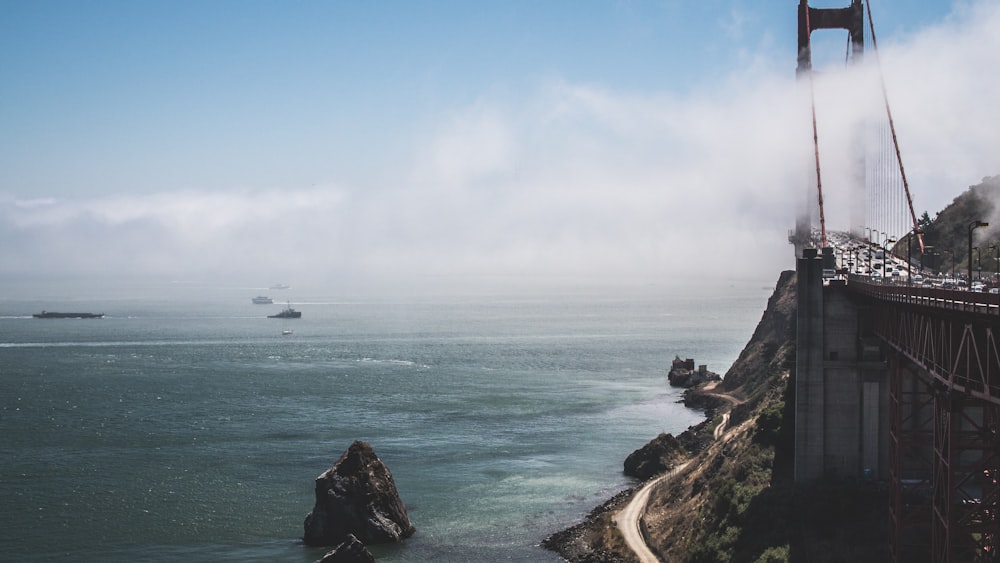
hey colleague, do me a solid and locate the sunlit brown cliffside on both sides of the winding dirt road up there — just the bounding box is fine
[544,272,795,561]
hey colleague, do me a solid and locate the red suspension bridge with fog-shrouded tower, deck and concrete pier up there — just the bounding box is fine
[789,0,1000,563]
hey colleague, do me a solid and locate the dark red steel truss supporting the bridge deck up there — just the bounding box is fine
[849,280,1000,563]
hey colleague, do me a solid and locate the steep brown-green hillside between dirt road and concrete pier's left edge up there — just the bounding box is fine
[643,272,796,561]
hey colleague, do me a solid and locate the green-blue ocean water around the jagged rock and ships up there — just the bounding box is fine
[0,284,771,562]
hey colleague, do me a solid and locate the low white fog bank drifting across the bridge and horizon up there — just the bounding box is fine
[0,3,1000,296]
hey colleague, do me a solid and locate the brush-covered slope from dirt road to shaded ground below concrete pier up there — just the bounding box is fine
[645,272,888,563]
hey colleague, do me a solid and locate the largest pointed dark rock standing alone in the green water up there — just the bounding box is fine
[302,441,416,546]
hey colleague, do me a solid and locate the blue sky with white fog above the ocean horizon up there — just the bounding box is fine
[0,0,1000,296]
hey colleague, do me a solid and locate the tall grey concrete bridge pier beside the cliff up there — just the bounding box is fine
[794,249,889,481]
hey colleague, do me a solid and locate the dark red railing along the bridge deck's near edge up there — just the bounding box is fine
[847,275,1000,315]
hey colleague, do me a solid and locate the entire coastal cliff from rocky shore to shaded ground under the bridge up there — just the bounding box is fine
[543,271,888,563]
